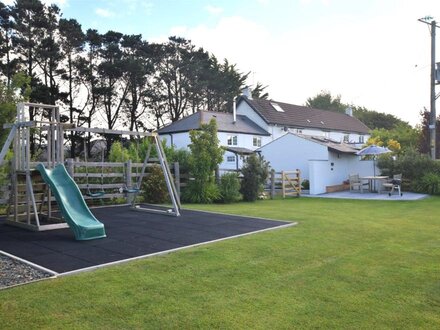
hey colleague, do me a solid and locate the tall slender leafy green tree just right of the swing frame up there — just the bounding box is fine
[184,119,224,203]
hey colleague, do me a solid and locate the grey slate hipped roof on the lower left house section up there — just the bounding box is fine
[158,111,270,136]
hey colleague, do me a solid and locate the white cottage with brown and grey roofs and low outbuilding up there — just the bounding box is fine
[159,90,373,194]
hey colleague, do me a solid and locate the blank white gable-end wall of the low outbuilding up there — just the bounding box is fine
[260,134,328,179]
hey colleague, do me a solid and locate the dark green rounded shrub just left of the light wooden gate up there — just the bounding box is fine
[241,154,269,202]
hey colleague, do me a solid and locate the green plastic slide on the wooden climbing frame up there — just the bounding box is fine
[37,164,106,241]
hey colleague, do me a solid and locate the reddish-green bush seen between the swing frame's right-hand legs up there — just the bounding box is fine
[142,165,169,204]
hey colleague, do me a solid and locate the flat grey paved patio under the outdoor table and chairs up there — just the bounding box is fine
[301,190,429,201]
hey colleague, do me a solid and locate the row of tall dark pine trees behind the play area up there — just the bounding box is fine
[0,0,258,154]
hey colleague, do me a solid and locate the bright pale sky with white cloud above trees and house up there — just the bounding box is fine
[2,0,440,126]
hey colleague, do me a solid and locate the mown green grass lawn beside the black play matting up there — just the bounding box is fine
[0,197,440,329]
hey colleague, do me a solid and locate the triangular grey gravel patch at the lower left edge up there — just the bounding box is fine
[0,254,52,289]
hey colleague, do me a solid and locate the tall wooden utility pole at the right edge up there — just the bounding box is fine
[419,16,439,160]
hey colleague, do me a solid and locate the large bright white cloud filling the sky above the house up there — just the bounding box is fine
[165,0,435,125]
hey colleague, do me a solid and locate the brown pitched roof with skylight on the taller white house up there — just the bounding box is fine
[238,96,369,134]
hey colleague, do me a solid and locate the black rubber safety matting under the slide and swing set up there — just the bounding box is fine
[0,206,289,273]
